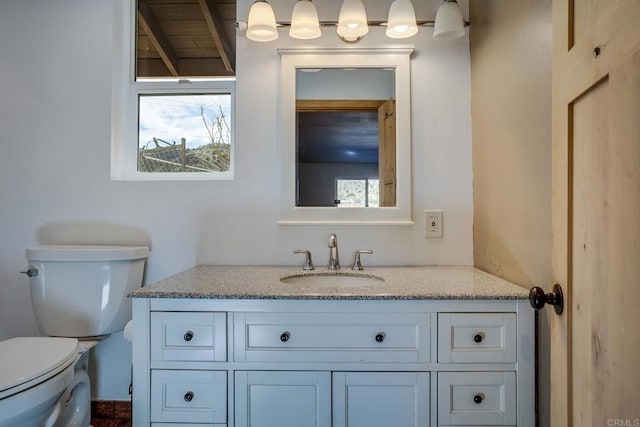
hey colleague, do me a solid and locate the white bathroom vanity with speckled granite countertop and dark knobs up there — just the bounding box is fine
[131,266,535,427]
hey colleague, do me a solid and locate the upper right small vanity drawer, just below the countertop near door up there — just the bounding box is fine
[438,313,516,363]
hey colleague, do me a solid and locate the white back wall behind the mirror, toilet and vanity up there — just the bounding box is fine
[0,0,473,399]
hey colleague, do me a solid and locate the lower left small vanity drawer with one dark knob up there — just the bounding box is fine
[151,370,227,425]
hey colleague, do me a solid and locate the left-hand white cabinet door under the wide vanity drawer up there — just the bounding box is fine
[235,371,331,427]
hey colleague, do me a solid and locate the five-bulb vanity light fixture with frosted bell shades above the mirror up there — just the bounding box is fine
[240,0,471,43]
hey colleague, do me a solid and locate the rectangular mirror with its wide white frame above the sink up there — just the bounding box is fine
[279,47,413,224]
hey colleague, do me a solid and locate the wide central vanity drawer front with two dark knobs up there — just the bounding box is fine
[234,313,430,362]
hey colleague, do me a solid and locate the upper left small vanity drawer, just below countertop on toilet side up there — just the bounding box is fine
[151,312,227,362]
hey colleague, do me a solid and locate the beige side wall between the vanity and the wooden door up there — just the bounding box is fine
[471,0,553,427]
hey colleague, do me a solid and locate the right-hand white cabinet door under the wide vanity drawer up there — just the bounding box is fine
[333,372,429,427]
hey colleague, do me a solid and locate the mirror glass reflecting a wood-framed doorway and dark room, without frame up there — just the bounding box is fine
[296,68,396,207]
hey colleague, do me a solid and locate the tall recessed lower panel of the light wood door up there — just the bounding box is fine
[571,51,640,425]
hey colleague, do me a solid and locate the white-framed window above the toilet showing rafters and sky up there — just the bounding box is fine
[111,0,235,180]
